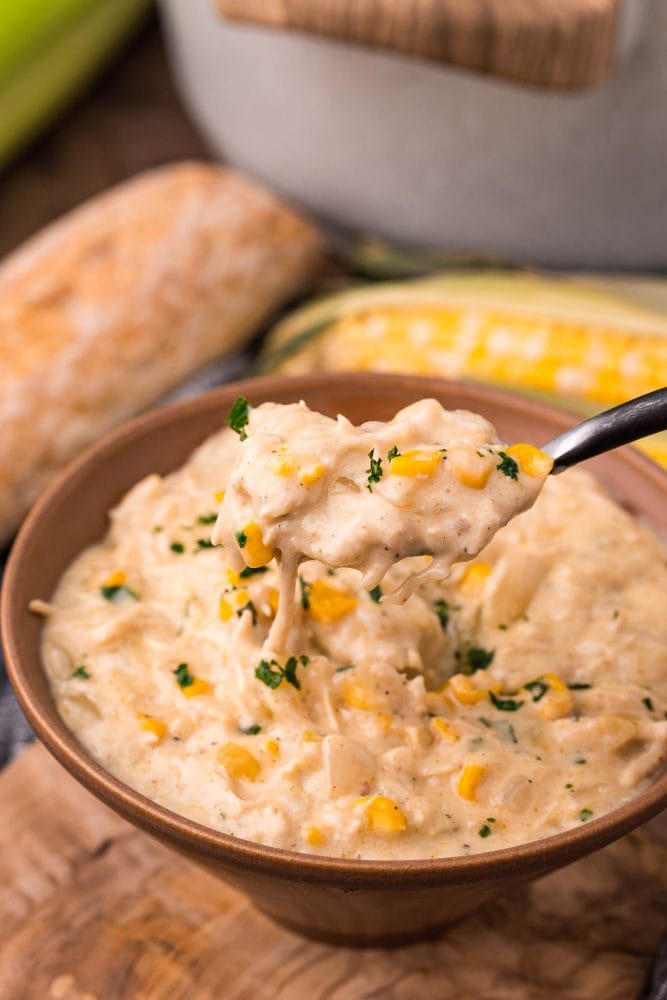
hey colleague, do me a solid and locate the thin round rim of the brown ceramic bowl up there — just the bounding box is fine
[0,372,667,889]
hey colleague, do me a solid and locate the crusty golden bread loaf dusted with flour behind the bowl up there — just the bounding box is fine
[0,163,321,543]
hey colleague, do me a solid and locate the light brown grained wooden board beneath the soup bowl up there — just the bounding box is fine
[0,746,667,1000]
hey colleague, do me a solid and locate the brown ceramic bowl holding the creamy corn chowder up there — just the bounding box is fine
[1,373,667,945]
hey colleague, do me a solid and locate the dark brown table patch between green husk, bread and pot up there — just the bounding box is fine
[0,17,207,256]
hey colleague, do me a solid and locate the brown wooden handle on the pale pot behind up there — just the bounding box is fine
[217,0,619,88]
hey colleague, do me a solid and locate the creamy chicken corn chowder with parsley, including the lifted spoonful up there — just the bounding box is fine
[34,399,667,859]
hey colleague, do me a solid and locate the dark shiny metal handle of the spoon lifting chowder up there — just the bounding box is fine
[542,387,667,473]
